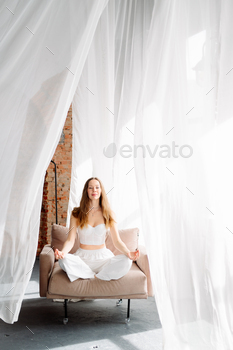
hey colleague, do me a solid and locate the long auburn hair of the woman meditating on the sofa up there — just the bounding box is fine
[71,177,116,229]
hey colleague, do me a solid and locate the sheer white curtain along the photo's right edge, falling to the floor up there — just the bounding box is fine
[135,0,233,350]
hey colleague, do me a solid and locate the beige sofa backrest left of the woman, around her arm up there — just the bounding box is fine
[51,224,79,254]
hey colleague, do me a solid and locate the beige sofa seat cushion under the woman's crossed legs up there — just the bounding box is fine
[48,262,147,299]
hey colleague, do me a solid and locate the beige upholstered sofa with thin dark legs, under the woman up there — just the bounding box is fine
[40,224,153,324]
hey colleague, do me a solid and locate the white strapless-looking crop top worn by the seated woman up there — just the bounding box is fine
[78,224,107,245]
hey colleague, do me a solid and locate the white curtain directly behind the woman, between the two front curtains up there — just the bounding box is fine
[67,0,154,232]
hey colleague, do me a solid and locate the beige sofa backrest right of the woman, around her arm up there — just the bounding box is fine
[105,227,139,255]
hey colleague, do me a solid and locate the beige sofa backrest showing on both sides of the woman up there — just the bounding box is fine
[51,224,139,255]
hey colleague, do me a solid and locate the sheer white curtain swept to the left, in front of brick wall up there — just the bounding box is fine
[0,0,107,323]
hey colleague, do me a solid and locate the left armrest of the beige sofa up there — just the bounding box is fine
[40,244,55,297]
